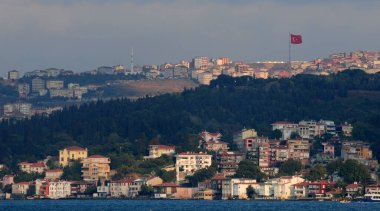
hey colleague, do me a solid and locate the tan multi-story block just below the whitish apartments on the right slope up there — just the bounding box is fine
[287,139,310,164]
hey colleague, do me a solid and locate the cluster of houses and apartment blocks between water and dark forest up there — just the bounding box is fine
[0,120,380,200]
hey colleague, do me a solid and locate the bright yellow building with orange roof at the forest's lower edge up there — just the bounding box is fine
[59,146,88,167]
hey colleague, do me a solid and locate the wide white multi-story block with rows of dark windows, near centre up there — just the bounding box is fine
[175,152,212,182]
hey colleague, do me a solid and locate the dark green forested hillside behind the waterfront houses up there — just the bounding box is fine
[0,70,380,167]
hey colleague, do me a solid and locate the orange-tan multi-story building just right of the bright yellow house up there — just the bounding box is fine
[82,155,111,182]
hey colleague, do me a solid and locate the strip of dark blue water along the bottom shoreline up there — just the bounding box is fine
[0,200,380,211]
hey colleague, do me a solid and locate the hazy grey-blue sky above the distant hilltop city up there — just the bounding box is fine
[0,0,380,75]
